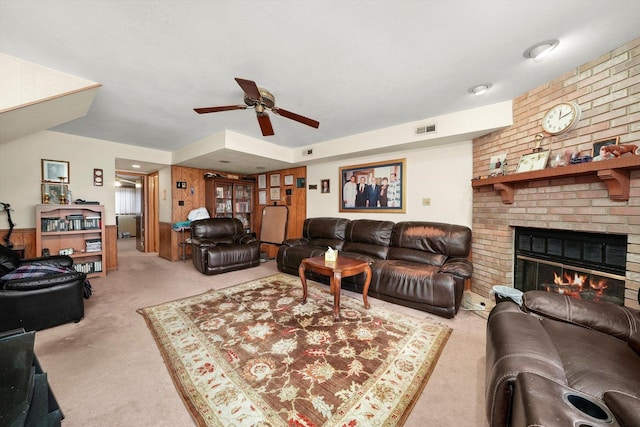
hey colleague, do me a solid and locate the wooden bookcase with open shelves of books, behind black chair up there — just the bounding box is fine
[36,205,107,277]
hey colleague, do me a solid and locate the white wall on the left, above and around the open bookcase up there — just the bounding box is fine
[0,131,171,228]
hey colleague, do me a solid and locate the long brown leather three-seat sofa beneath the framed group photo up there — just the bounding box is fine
[277,218,473,318]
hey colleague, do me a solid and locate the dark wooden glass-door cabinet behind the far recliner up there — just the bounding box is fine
[205,178,254,233]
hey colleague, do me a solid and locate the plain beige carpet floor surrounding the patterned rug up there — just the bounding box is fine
[31,238,487,427]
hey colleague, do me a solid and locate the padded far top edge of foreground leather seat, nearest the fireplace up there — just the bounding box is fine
[523,291,640,341]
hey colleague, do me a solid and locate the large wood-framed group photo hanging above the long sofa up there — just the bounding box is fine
[340,159,407,213]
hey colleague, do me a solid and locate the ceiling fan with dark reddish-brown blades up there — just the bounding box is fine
[193,77,320,136]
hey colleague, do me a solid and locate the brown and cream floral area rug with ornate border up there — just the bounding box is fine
[138,274,451,427]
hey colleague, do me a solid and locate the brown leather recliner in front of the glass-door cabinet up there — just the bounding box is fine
[191,218,260,275]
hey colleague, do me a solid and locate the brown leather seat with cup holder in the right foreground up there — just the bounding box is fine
[485,291,640,427]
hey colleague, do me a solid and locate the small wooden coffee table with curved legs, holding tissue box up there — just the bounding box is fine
[298,255,371,320]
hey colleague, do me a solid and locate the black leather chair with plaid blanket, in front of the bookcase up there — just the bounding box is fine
[0,246,87,331]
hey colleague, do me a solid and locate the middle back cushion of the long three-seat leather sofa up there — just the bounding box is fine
[342,219,394,259]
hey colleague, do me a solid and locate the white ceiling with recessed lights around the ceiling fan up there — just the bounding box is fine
[0,0,640,174]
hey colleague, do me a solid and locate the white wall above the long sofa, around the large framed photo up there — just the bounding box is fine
[307,141,473,227]
